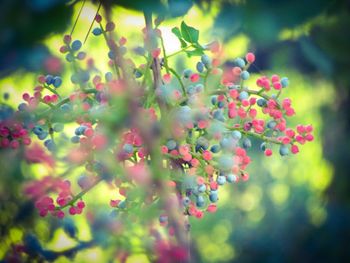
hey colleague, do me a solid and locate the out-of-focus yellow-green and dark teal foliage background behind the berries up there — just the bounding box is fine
[0,0,350,262]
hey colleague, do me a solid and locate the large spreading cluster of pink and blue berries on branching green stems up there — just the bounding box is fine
[0,15,313,232]
